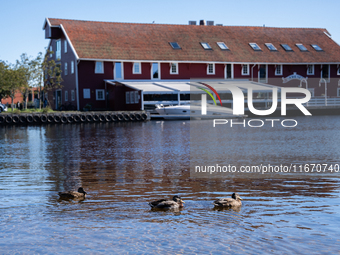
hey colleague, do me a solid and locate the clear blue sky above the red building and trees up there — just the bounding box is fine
[0,0,340,64]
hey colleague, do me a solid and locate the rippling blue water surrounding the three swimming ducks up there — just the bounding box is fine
[0,116,340,254]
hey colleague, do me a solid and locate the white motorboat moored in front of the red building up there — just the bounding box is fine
[151,104,246,119]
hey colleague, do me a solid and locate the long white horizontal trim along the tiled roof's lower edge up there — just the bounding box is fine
[79,58,340,65]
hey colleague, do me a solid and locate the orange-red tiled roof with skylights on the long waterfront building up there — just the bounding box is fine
[48,19,340,63]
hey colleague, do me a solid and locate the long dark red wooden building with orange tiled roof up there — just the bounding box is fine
[43,18,340,110]
